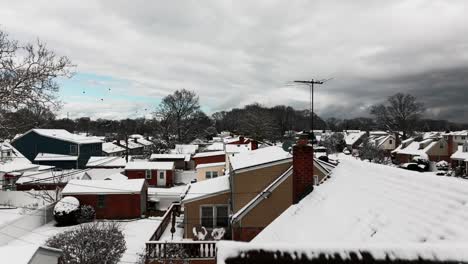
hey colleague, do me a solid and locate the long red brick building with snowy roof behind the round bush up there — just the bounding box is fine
[62,179,148,219]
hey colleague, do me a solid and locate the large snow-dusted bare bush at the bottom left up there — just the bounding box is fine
[46,222,127,264]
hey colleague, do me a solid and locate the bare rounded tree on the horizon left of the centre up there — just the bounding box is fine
[155,89,200,142]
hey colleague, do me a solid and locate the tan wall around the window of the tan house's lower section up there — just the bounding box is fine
[184,193,229,239]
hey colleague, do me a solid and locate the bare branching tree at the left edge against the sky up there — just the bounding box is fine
[0,30,73,140]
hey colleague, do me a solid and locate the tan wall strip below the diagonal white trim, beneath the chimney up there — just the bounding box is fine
[240,175,293,228]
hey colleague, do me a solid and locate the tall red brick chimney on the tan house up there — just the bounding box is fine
[292,137,314,204]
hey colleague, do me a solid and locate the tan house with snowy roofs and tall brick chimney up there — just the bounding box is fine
[182,141,333,241]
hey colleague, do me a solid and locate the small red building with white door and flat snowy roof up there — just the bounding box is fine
[125,161,175,187]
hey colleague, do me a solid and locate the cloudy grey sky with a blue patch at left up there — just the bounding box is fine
[0,0,468,122]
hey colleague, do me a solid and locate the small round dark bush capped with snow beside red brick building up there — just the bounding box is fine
[54,196,80,226]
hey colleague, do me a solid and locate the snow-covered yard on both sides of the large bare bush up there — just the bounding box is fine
[7,217,161,263]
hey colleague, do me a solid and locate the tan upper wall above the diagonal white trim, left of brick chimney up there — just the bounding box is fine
[232,161,292,213]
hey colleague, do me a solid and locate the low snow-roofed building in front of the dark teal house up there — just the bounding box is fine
[15,170,89,191]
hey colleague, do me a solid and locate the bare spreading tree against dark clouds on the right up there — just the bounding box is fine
[370,93,425,139]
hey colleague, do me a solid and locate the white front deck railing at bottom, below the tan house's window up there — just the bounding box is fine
[146,241,216,260]
